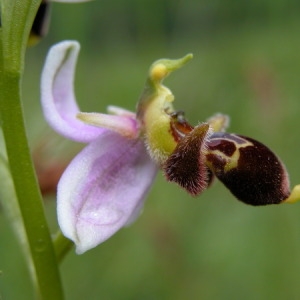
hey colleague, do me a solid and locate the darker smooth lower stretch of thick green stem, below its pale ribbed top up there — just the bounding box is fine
[0,72,63,300]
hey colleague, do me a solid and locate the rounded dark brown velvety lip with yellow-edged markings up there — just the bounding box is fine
[206,133,290,205]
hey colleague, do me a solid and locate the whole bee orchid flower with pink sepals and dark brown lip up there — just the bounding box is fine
[41,41,300,253]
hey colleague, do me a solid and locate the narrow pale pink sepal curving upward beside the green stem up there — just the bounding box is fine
[41,41,105,143]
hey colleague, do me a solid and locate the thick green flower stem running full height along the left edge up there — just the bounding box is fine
[0,0,63,300]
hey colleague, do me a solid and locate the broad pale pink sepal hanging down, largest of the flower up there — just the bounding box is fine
[57,131,157,254]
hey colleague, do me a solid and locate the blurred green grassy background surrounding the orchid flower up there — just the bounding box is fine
[0,0,300,300]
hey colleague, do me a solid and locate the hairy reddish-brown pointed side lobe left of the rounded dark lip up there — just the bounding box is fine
[163,123,213,196]
